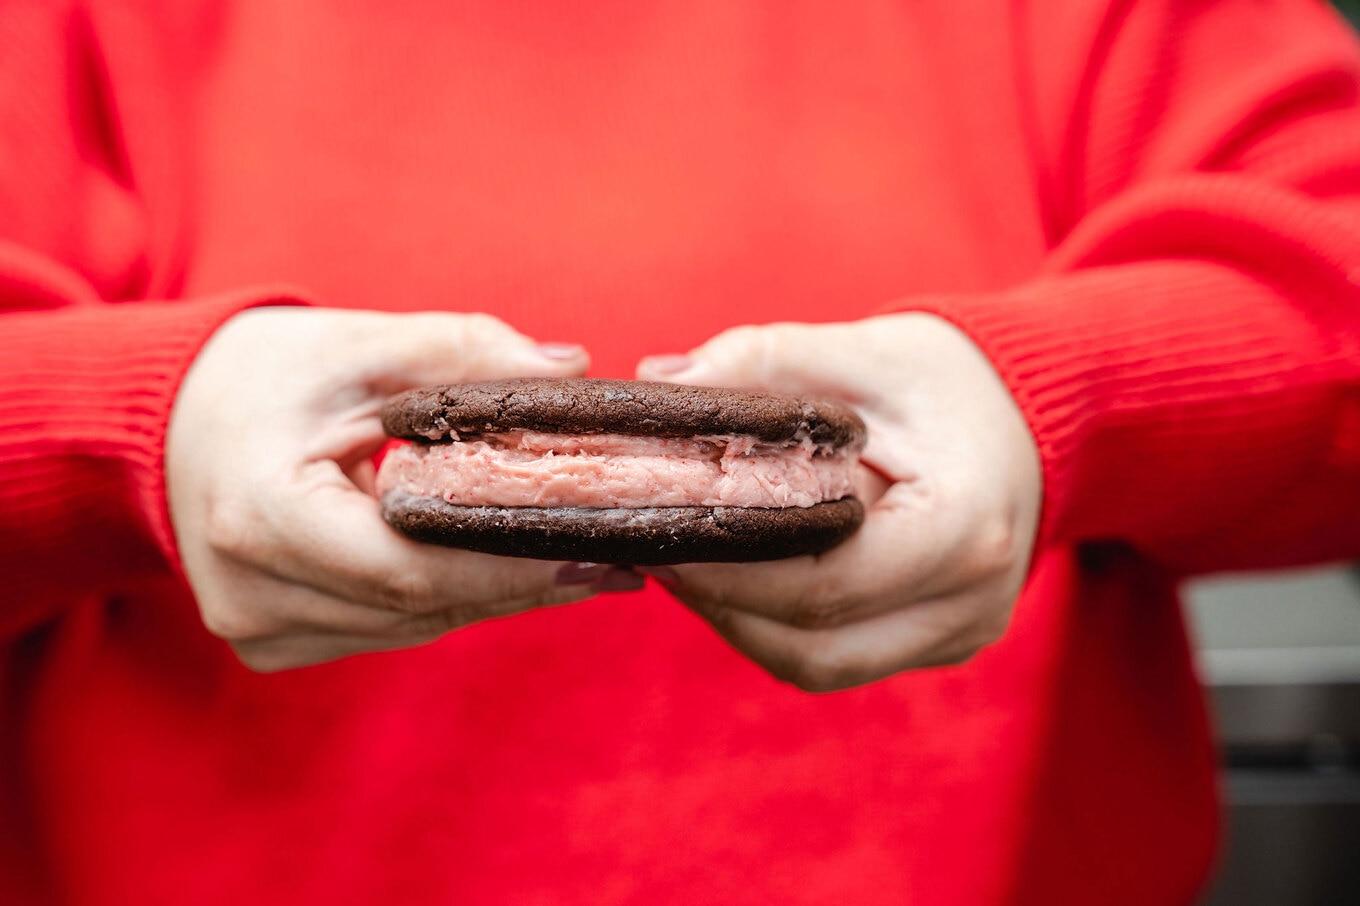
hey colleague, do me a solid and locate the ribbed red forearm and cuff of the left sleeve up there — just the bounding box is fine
[0,278,306,625]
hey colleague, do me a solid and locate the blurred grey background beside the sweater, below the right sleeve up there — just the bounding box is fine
[1187,10,1360,906]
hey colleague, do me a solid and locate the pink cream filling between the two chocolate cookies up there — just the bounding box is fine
[378,431,858,509]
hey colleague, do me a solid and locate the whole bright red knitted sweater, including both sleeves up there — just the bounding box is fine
[0,0,1360,906]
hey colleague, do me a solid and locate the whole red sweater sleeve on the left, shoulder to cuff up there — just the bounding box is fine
[0,3,308,638]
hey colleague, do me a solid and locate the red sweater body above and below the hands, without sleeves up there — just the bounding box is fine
[5,0,1212,903]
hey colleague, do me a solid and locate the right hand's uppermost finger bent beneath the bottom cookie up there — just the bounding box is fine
[643,483,1012,628]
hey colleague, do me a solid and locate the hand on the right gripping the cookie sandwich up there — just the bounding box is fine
[638,314,1040,691]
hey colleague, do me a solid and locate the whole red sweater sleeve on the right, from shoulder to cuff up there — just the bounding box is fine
[900,0,1360,573]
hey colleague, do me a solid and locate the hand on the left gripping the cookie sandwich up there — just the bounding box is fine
[166,307,617,671]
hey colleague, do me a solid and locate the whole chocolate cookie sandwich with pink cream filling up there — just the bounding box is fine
[378,378,865,565]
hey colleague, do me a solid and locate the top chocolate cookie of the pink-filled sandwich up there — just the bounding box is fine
[382,378,865,446]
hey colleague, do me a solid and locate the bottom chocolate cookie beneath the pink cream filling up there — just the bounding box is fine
[382,491,864,566]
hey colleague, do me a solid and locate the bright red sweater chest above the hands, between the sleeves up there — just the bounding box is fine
[178,1,1043,375]
